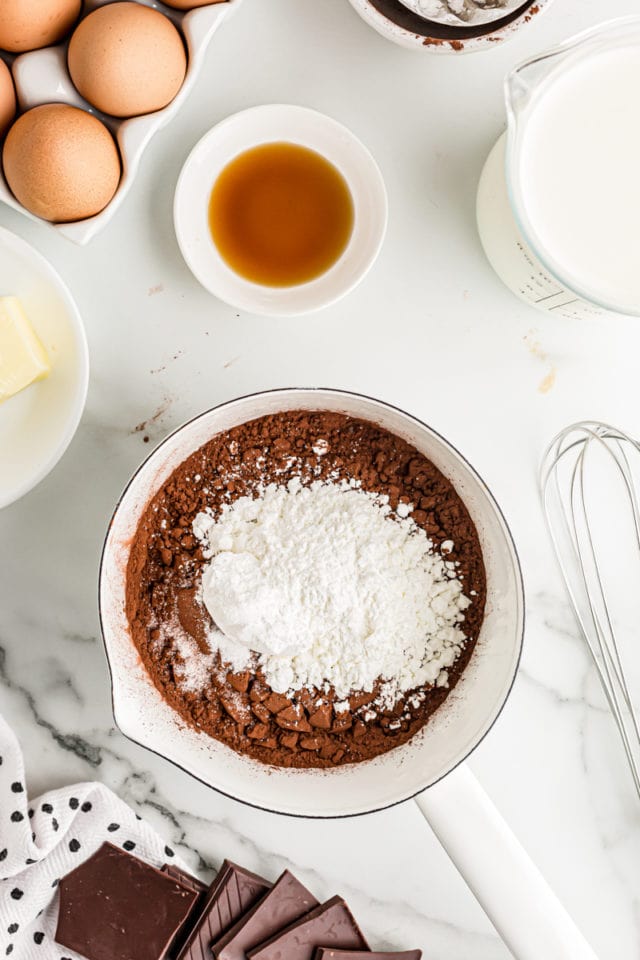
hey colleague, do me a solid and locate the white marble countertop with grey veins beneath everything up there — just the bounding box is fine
[0,0,640,960]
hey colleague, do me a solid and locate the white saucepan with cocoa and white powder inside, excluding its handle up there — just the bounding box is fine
[100,389,523,816]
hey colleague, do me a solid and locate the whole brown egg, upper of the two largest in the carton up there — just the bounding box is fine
[68,2,187,117]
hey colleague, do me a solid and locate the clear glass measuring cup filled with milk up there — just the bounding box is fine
[477,16,640,318]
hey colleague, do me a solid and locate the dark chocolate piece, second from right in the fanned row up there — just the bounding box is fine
[247,897,369,960]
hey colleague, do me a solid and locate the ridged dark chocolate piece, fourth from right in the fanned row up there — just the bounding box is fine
[176,860,272,960]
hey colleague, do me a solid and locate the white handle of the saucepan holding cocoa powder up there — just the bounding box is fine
[416,765,597,960]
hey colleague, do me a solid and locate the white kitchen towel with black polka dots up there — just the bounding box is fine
[0,716,189,960]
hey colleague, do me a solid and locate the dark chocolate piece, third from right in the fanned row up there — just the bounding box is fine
[211,870,318,960]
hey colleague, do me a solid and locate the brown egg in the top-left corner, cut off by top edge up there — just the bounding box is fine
[0,0,82,53]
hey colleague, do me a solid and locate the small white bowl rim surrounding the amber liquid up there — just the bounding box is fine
[174,104,387,316]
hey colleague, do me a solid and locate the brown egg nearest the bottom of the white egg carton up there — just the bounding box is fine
[2,103,120,223]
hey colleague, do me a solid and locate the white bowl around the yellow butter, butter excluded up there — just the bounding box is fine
[0,228,89,508]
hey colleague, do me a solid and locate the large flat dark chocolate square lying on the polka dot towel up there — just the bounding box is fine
[56,843,197,960]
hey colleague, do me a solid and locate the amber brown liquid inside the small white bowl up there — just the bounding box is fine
[209,143,354,287]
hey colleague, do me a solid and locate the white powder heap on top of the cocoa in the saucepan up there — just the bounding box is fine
[193,480,470,707]
